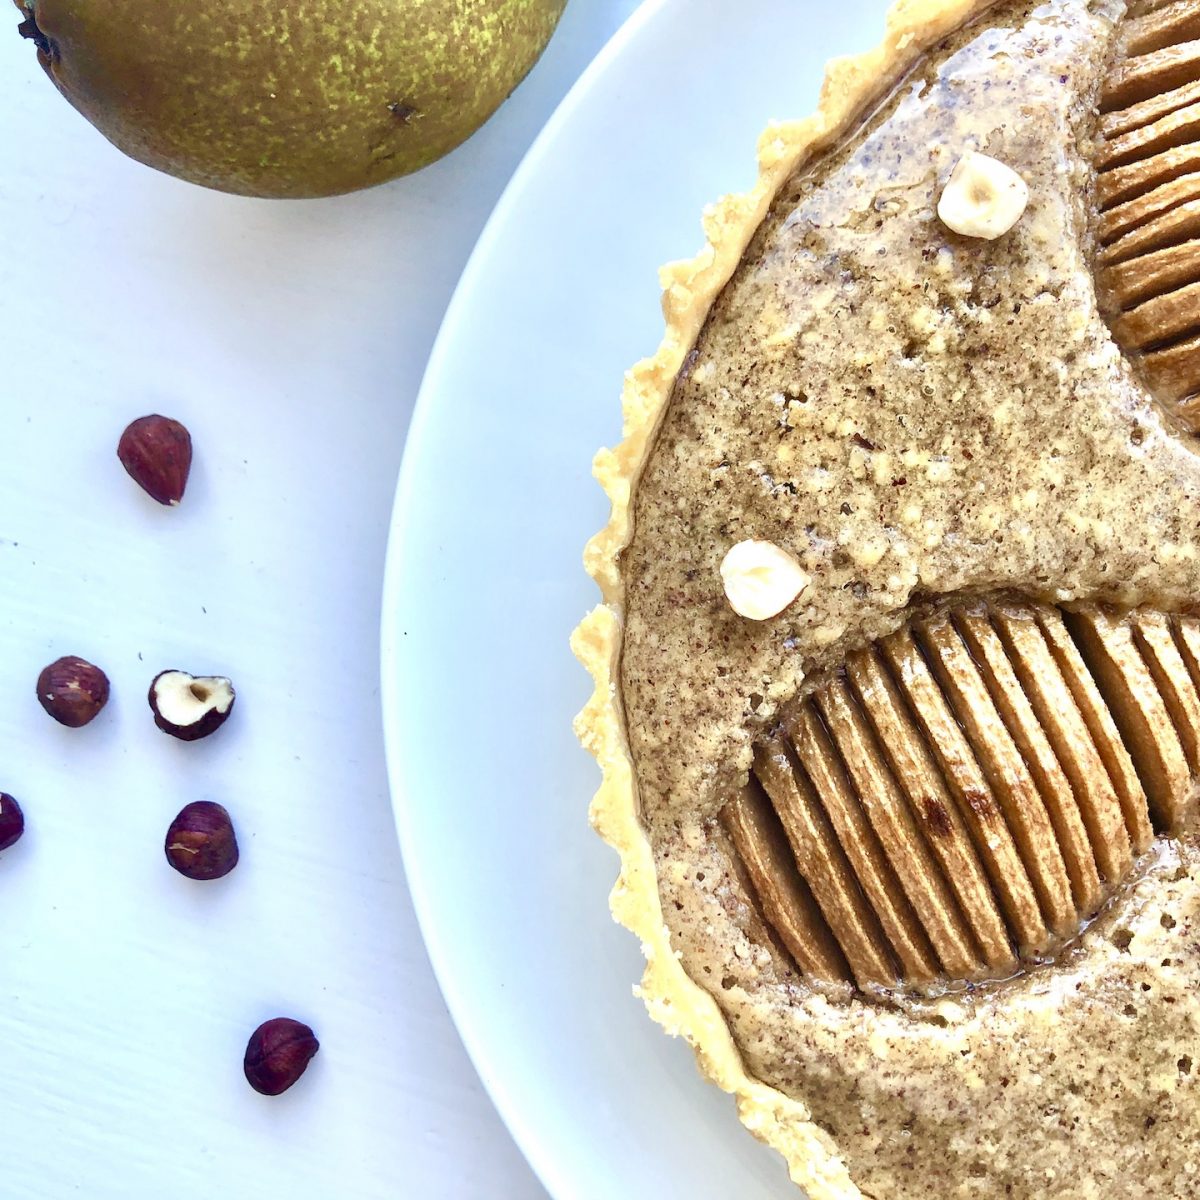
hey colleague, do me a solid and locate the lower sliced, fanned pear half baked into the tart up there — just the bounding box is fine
[721,598,1200,990]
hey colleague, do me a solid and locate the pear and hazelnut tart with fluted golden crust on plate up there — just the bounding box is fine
[574,0,1200,1200]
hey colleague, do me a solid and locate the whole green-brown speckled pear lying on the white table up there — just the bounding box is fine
[17,0,565,197]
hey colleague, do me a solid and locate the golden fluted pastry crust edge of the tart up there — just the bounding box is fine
[571,0,995,1200]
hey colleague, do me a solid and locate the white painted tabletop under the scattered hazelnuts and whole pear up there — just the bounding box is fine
[0,0,636,1200]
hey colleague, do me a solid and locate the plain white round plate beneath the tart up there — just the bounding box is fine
[383,0,882,1200]
